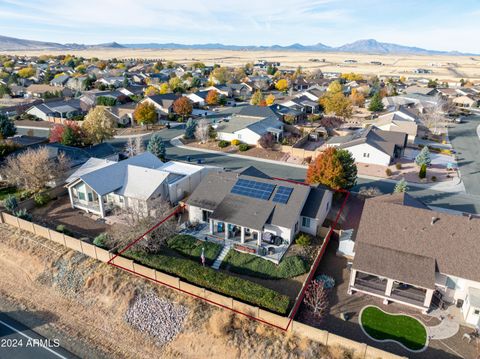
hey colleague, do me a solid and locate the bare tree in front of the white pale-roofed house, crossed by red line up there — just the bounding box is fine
[108,198,177,253]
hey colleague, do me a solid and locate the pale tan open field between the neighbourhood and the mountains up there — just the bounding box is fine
[3,49,480,81]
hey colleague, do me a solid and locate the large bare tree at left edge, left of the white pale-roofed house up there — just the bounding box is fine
[2,147,70,192]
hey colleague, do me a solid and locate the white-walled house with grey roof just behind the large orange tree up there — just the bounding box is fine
[326,126,408,166]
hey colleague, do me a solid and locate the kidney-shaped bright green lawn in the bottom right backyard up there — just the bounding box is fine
[360,306,427,350]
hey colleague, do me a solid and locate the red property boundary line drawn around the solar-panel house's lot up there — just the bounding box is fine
[107,177,350,331]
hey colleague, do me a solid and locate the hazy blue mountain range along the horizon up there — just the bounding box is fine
[0,36,475,56]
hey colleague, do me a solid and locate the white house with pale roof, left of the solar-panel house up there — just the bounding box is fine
[66,152,220,218]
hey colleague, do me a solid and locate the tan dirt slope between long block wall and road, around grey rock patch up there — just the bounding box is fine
[0,224,352,358]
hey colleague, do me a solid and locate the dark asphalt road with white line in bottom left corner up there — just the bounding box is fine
[0,313,77,359]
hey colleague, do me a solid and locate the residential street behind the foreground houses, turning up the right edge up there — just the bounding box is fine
[110,125,480,213]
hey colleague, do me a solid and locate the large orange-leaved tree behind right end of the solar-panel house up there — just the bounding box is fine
[305,147,357,189]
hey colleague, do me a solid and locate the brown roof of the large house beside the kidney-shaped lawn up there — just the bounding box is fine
[353,194,480,286]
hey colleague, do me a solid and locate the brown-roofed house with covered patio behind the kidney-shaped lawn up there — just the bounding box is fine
[348,193,480,326]
